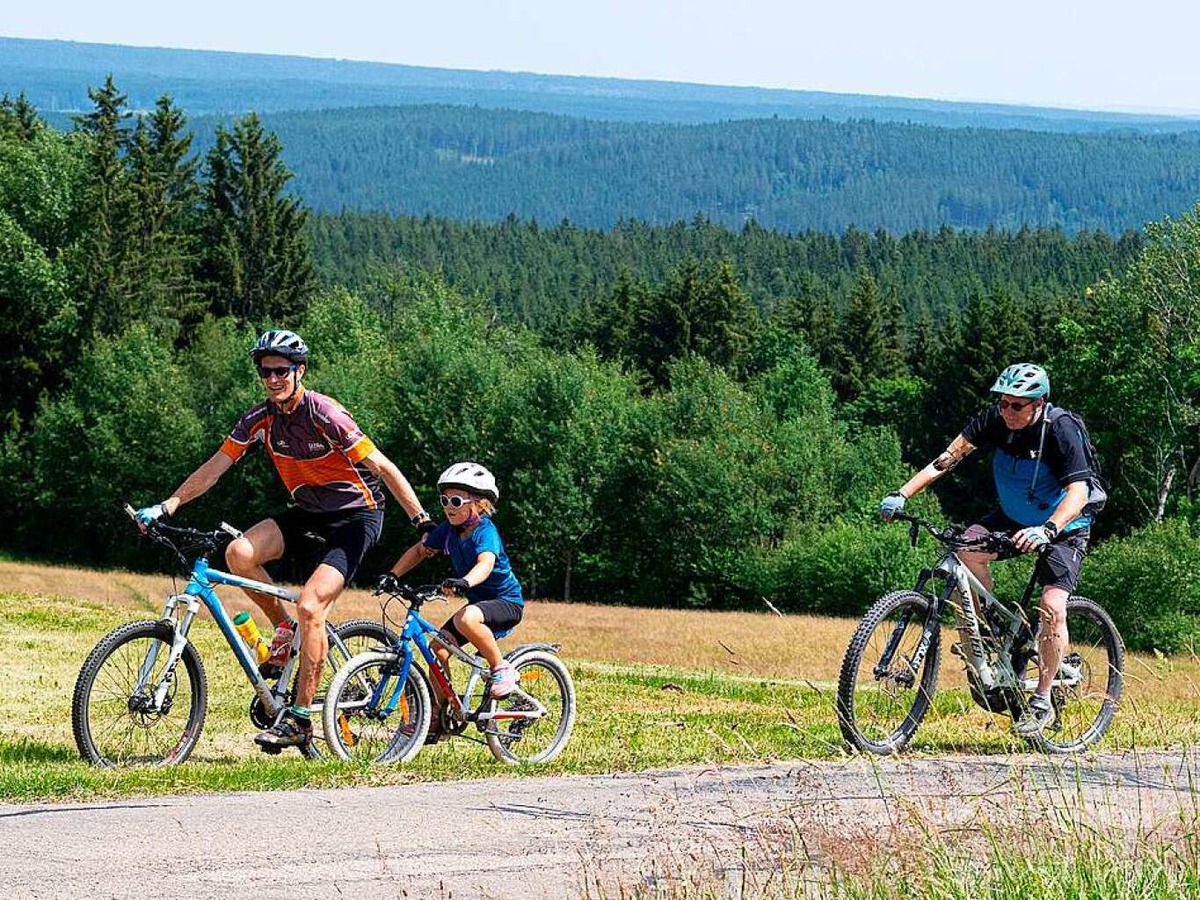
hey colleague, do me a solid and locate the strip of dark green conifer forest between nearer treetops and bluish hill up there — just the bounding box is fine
[308,211,1142,342]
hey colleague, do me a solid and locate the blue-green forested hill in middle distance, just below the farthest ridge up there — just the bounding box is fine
[255,106,1200,233]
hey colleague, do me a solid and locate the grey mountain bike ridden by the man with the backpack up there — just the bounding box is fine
[836,514,1124,755]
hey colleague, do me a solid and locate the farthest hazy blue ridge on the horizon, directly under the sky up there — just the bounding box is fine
[7,37,1200,133]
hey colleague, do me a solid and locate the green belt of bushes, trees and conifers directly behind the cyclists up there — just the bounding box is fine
[7,82,1200,652]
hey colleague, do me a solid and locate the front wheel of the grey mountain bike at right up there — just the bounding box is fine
[835,590,941,756]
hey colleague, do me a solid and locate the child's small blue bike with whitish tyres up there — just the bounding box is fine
[323,584,575,764]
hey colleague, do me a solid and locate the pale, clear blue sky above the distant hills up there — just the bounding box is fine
[0,0,1200,113]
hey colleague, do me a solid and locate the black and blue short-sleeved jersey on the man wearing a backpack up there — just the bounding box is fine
[962,406,1092,533]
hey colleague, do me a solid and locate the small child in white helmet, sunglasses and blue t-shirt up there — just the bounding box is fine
[384,462,524,715]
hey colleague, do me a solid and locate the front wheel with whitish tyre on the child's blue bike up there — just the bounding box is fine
[322,652,432,763]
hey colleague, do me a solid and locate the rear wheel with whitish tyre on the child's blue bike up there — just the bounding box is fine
[485,650,575,766]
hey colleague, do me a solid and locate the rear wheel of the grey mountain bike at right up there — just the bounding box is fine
[1027,596,1124,755]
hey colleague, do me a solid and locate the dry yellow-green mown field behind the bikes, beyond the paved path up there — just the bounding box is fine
[0,562,1200,802]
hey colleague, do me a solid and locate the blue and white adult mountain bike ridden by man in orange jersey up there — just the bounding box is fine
[71,506,391,766]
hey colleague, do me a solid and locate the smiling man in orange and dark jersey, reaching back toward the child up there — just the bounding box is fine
[137,330,433,749]
